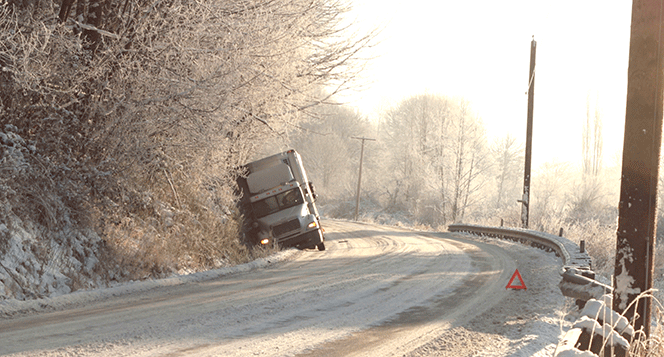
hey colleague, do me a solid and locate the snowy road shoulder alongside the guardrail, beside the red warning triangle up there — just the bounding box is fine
[408,229,576,357]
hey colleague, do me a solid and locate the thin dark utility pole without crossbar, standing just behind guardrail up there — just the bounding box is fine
[519,36,537,228]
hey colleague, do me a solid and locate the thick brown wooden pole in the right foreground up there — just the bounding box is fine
[613,0,664,337]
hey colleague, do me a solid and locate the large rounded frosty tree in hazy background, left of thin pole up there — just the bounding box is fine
[382,94,489,225]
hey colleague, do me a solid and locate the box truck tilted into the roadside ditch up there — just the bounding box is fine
[237,150,325,251]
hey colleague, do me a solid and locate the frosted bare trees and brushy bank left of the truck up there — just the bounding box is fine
[0,0,374,299]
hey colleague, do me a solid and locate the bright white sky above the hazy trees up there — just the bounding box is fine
[349,0,632,167]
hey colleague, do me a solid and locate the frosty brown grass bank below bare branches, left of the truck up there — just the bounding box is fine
[0,121,270,300]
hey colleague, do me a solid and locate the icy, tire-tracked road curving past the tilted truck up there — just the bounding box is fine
[0,221,565,356]
